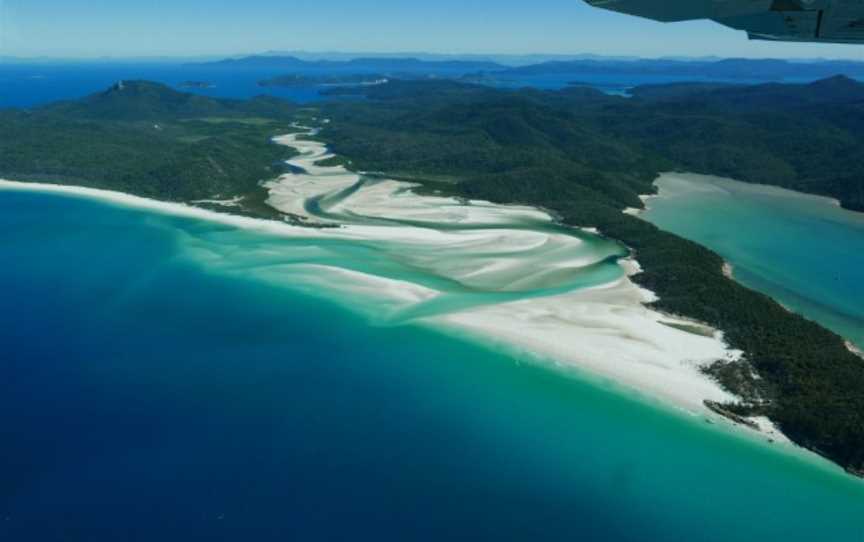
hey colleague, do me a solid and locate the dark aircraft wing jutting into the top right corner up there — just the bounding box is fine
[586,0,864,43]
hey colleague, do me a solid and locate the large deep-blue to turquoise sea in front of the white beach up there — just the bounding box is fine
[0,191,864,541]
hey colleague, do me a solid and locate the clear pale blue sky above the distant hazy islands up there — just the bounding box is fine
[0,0,864,60]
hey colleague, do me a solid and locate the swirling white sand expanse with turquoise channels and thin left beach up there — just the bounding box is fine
[0,131,760,416]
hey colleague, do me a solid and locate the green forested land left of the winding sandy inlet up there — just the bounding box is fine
[0,81,298,217]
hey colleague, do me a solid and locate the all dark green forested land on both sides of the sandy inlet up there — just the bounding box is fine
[0,77,864,474]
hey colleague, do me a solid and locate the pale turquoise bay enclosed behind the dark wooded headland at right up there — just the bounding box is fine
[642,175,864,347]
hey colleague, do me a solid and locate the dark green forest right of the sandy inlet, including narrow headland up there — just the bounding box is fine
[322,78,864,474]
